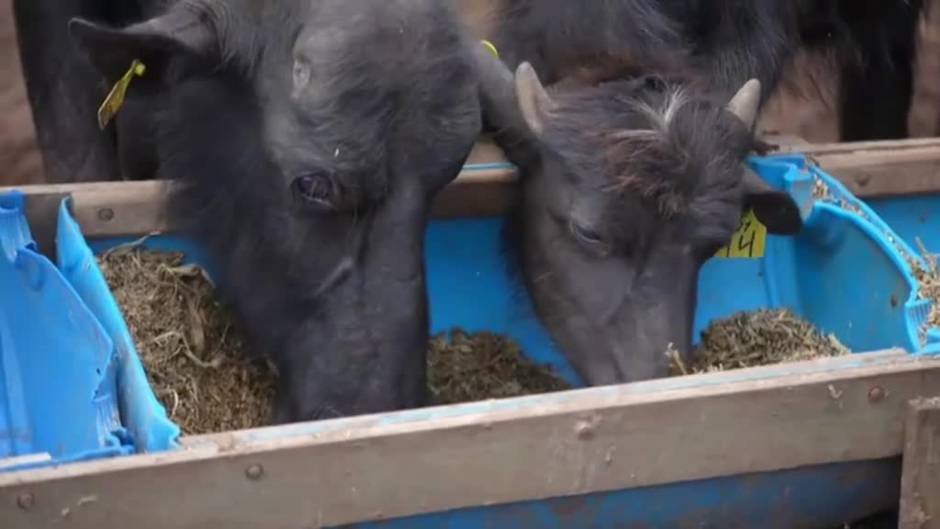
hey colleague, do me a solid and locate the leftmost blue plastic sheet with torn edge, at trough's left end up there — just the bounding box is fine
[0,193,133,470]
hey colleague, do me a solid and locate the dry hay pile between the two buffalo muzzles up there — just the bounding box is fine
[428,330,570,404]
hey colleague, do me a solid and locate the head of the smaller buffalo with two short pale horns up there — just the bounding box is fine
[466,0,802,385]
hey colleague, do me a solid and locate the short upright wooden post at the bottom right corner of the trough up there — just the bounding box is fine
[898,396,940,529]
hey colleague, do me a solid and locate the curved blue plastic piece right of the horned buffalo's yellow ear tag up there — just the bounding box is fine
[752,156,940,354]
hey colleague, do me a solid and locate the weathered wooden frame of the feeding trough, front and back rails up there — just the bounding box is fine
[0,139,940,529]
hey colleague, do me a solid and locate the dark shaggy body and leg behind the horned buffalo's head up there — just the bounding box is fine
[458,0,924,141]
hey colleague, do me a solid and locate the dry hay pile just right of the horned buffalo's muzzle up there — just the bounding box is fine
[666,309,850,375]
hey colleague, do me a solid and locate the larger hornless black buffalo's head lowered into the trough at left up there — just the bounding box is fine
[40,0,480,421]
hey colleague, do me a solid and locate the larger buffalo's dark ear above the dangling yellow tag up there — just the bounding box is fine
[69,6,218,81]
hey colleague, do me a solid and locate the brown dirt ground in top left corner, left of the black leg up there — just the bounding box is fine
[0,0,43,186]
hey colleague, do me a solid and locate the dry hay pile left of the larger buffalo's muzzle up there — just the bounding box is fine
[98,245,274,435]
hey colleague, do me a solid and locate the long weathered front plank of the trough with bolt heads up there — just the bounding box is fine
[0,352,940,529]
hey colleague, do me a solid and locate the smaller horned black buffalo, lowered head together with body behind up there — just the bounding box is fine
[460,0,919,384]
